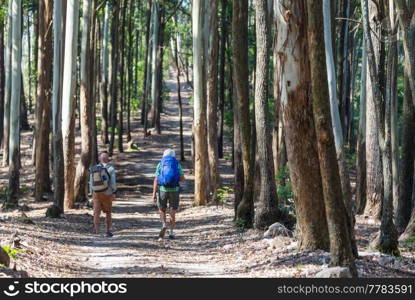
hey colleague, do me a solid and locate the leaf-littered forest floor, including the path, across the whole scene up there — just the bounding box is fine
[0,74,415,277]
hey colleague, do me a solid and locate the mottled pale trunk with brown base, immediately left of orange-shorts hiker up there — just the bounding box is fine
[75,1,94,203]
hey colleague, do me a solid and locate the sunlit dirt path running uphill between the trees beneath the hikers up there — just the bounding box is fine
[76,74,237,277]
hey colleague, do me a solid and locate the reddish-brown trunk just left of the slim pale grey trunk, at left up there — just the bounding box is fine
[35,0,53,201]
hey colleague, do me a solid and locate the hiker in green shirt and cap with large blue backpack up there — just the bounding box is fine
[153,149,185,240]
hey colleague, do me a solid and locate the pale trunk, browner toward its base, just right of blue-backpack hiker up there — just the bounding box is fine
[193,0,208,205]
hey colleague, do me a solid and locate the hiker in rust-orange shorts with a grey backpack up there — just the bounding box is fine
[89,152,117,237]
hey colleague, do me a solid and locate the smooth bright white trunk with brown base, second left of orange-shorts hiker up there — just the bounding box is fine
[62,0,79,209]
